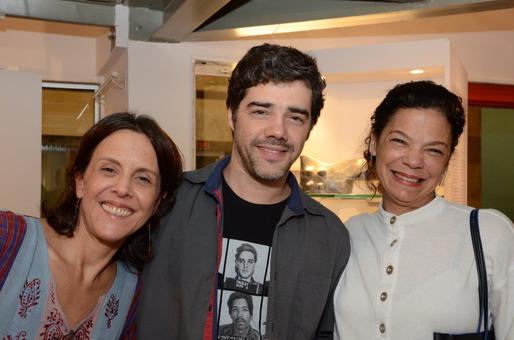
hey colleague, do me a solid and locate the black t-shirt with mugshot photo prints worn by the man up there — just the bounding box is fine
[218,178,287,340]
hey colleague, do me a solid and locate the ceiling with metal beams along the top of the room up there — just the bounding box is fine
[0,0,514,42]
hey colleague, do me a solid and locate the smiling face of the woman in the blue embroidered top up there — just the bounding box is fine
[75,130,160,248]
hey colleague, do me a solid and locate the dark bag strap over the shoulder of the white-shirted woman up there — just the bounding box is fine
[469,209,489,340]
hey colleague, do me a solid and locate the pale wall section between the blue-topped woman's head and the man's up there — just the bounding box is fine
[128,41,253,169]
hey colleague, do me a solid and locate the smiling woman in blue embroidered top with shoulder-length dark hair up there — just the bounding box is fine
[0,113,182,339]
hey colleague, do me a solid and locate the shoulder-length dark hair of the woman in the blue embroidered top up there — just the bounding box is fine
[42,112,182,271]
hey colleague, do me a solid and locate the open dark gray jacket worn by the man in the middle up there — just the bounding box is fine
[137,158,350,340]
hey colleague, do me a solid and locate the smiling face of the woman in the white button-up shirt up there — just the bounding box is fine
[372,108,452,214]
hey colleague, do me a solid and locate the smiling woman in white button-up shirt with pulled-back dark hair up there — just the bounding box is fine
[334,81,514,340]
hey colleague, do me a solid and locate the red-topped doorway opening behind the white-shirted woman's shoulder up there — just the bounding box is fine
[468,83,514,219]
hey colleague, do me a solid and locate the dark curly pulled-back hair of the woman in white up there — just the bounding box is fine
[364,80,466,193]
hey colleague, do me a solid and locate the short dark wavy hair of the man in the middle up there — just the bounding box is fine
[227,44,326,128]
